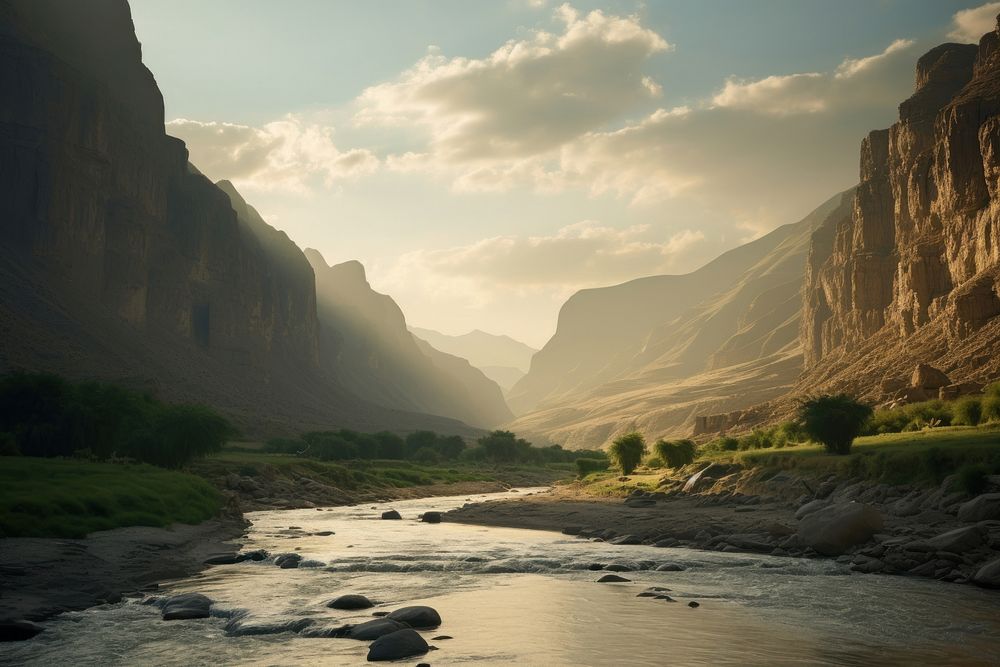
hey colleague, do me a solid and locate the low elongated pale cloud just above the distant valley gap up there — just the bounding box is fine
[382,221,705,293]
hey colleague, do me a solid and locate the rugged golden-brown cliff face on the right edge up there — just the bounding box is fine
[802,17,1000,396]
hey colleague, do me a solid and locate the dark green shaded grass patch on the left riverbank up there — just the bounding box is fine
[0,456,221,537]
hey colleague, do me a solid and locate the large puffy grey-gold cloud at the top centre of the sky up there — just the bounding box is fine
[355,5,670,163]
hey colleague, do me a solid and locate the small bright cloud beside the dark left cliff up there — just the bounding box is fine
[167,115,379,191]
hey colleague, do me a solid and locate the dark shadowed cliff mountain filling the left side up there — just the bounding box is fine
[0,0,480,433]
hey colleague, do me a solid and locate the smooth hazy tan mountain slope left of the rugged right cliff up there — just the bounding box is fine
[508,193,851,447]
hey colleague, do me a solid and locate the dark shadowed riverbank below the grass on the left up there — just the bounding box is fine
[0,516,248,639]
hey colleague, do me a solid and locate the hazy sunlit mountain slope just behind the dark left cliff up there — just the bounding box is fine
[305,249,512,427]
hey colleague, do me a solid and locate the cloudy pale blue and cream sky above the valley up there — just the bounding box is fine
[131,0,1000,347]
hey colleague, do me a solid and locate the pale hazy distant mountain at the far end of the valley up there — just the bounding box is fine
[410,327,538,392]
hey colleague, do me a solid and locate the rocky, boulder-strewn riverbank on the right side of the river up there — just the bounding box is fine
[443,464,1000,588]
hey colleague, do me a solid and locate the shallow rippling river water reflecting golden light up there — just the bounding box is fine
[0,489,1000,667]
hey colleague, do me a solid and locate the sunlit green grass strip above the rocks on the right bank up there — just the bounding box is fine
[702,425,1000,484]
